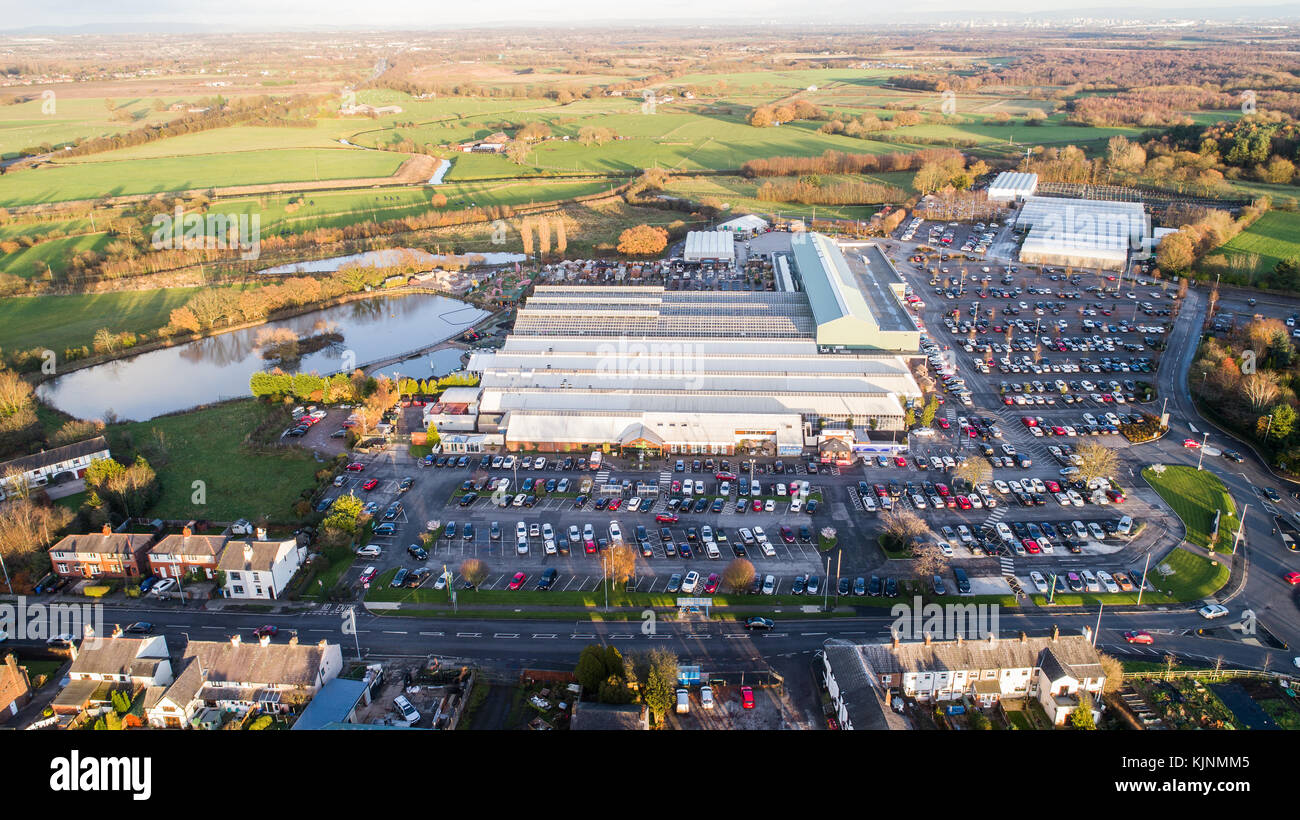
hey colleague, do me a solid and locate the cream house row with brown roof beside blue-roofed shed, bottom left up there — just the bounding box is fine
[144,634,343,729]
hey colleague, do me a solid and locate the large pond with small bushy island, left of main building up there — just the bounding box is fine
[36,294,488,421]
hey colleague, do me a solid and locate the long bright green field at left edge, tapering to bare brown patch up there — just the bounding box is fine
[0,147,406,205]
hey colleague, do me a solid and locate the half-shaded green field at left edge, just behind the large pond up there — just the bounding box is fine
[0,287,215,355]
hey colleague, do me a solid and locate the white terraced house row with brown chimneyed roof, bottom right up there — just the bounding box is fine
[854,628,1106,725]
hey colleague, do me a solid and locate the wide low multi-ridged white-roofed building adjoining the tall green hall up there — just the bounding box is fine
[469,235,920,455]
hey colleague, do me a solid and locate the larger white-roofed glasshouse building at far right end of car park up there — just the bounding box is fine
[1015,196,1151,270]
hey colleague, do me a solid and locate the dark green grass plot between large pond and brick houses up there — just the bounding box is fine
[108,399,321,522]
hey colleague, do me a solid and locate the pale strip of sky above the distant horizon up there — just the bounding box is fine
[0,0,1300,31]
